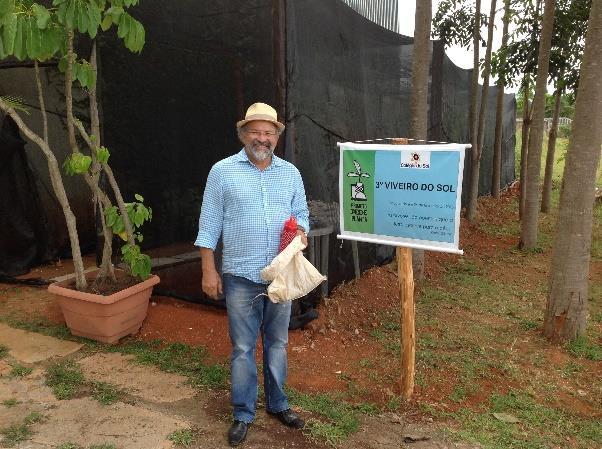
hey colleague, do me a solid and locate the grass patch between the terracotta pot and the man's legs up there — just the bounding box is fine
[105,340,229,388]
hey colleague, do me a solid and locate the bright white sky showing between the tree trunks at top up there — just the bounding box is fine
[398,0,516,92]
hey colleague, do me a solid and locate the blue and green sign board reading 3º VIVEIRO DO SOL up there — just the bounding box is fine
[338,142,469,254]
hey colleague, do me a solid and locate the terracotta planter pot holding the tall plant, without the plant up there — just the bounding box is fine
[48,275,160,343]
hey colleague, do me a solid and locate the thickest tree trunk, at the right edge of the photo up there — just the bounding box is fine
[544,0,602,342]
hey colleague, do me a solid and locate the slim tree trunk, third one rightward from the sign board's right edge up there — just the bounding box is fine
[491,0,510,198]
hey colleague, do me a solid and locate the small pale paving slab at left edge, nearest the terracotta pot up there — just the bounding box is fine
[0,323,83,363]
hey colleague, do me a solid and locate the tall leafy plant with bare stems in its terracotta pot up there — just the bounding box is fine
[0,0,159,343]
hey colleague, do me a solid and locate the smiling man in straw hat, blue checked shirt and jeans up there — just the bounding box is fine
[195,103,309,446]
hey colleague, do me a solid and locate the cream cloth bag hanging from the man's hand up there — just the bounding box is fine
[260,235,326,303]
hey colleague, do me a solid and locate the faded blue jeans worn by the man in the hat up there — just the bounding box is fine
[223,273,291,423]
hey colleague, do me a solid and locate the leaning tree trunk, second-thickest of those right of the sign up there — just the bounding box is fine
[519,0,556,249]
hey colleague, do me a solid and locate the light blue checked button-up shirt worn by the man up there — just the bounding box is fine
[194,148,309,284]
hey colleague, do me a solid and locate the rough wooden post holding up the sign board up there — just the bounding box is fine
[392,138,416,399]
